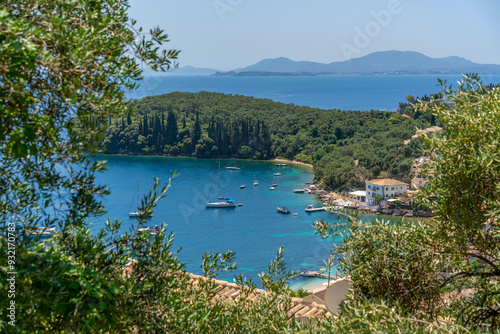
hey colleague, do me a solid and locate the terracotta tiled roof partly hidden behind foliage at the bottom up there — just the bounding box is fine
[189,273,332,320]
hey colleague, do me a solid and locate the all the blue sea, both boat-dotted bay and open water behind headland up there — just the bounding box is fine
[92,75,500,289]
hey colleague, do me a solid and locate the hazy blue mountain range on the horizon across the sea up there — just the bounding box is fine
[180,51,500,76]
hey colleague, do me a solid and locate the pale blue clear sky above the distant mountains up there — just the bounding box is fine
[129,0,500,70]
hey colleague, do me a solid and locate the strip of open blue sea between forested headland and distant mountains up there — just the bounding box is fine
[131,75,500,110]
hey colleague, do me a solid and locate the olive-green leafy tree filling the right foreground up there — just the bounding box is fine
[315,75,500,333]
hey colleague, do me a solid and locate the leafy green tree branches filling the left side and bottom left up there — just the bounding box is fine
[0,0,296,333]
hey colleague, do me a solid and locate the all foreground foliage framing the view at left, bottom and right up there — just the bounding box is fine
[0,0,500,333]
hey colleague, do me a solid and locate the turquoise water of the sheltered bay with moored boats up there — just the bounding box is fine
[93,156,342,282]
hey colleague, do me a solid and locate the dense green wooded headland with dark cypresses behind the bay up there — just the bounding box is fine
[103,92,433,188]
